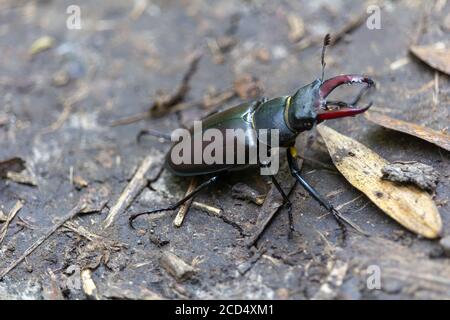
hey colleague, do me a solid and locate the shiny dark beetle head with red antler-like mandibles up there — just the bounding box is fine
[287,75,375,132]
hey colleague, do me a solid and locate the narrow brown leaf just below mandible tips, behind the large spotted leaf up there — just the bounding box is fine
[365,112,450,151]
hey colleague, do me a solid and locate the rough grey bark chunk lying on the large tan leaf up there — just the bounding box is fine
[381,161,439,191]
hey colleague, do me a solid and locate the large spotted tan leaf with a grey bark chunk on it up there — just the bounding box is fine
[318,125,442,238]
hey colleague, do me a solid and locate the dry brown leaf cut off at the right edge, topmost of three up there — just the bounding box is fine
[410,45,450,75]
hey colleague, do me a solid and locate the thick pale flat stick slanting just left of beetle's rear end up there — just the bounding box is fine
[103,156,153,229]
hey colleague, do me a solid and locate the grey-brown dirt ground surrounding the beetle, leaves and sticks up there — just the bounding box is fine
[0,0,450,299]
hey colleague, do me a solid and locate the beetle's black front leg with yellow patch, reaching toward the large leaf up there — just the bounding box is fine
[287,147,368,241]
